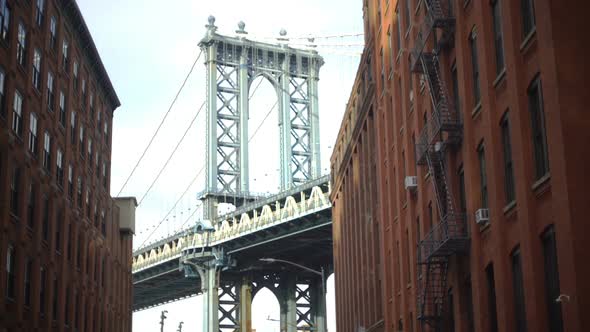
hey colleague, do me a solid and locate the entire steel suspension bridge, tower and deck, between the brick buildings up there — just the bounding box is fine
[132,16,356,332]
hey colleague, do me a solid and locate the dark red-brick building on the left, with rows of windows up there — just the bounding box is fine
[0,0,135,331]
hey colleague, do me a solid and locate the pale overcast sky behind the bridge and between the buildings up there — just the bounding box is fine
[78,0,363,332]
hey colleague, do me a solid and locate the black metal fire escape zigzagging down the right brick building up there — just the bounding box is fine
[411,0,469,331]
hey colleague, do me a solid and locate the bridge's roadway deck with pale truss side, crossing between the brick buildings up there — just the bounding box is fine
[133,177,332,311]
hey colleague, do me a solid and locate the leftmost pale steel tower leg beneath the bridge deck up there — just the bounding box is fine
[199,261,219,332]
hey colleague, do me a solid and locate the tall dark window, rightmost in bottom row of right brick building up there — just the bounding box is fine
[541,225,563,332]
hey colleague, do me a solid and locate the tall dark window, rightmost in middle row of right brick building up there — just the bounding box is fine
[528,77,549,180]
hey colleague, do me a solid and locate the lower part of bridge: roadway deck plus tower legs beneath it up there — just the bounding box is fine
[132,176,332,332]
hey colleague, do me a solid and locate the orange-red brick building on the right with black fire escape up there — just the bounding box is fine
[332,0,590,332]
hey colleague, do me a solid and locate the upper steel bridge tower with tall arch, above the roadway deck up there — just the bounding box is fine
[199,17,324,219]
